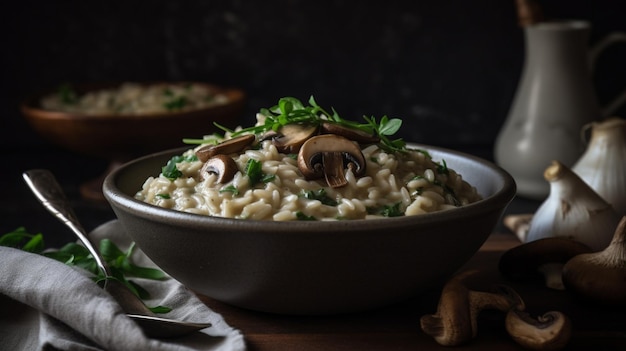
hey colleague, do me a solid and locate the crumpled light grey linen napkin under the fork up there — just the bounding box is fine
[0,221,246,351]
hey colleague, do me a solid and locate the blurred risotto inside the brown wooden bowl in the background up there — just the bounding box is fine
[41,82,228,115]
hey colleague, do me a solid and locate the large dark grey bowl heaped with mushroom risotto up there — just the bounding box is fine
[104,98,516,315]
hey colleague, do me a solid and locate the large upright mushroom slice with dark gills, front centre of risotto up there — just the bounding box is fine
[298,134,365,188]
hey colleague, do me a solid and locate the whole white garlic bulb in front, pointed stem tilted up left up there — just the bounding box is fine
[526,161,620,251]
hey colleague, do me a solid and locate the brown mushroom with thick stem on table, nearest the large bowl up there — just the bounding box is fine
[420,271,525,346]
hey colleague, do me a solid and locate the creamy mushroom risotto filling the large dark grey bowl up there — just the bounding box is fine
[136,110,481,221]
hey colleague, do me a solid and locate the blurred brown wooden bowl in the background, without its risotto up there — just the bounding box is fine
[21,82,245,200]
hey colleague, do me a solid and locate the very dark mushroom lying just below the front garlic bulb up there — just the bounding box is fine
[498,237,592,290]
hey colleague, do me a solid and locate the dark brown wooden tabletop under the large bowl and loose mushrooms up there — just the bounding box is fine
[203,234,626,351]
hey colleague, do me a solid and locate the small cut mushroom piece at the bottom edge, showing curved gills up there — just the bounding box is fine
[504,309,572,350]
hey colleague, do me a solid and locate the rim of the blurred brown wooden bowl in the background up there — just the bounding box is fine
[20,80,246,121]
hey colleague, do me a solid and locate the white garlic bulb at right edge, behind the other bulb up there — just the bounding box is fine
[572,117,626,215]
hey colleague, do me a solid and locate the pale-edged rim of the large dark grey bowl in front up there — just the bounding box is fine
[103,143,517,235]
